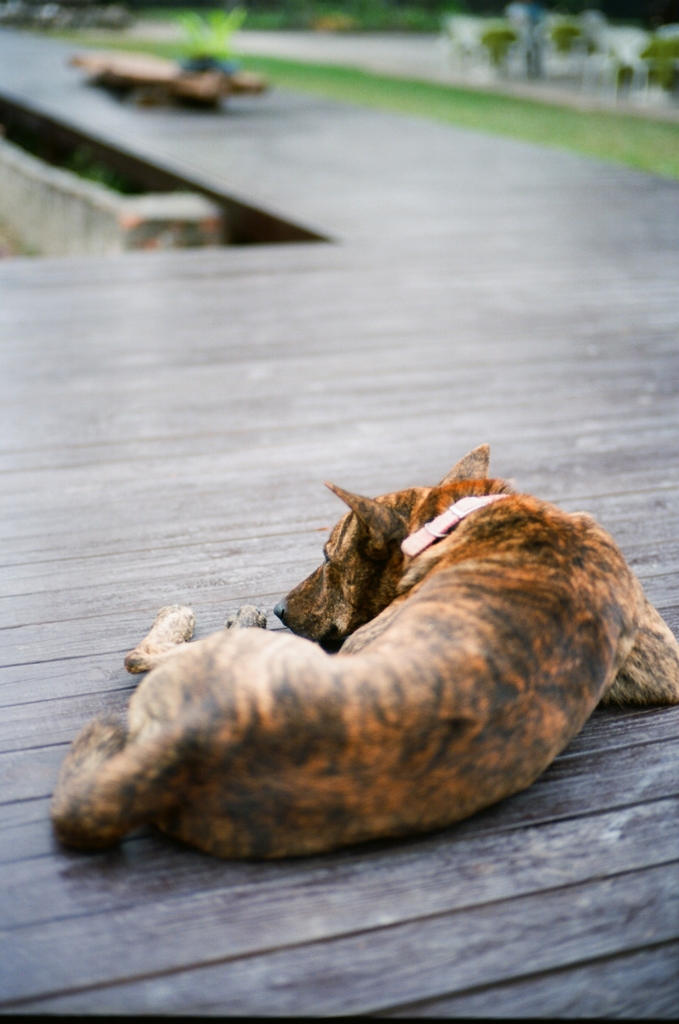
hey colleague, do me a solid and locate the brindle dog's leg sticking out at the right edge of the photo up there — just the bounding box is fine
[601,598,679,706]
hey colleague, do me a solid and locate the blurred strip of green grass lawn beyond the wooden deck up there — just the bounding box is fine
[61,36,679,179]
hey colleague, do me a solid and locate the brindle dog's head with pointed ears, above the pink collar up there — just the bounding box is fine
[274,444,491,650]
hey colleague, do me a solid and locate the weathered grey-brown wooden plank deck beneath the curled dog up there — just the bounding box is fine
[0,24,679,1018]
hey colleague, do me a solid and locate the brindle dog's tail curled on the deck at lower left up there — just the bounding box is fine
[50,717,188,849]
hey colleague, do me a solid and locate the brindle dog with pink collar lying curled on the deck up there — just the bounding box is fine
[52,445,679,857]
